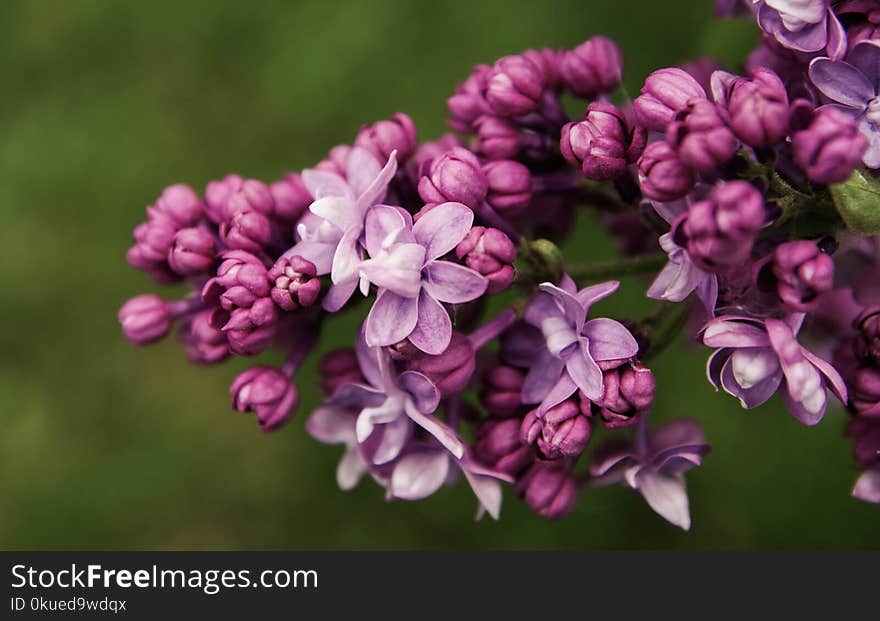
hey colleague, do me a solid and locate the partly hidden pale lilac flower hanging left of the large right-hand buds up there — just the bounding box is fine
[647,194,718,317]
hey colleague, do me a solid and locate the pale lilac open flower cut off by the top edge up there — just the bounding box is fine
[754,0,846,58]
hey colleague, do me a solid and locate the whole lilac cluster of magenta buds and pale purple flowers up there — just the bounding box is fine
[119,6,880,529]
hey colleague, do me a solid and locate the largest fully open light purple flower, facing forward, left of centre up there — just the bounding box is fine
[359,203,488,355]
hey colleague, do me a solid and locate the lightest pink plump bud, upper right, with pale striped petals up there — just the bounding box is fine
[633,67,706,132]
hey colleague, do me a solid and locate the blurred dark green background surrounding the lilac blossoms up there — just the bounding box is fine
[0,0,880,549]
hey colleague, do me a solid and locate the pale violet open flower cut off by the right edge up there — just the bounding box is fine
[810,41,880,168]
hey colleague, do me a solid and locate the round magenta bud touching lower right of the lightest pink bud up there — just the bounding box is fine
[666,99,739,173]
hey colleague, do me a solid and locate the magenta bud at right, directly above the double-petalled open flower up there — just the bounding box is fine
[758,240,834,312]
